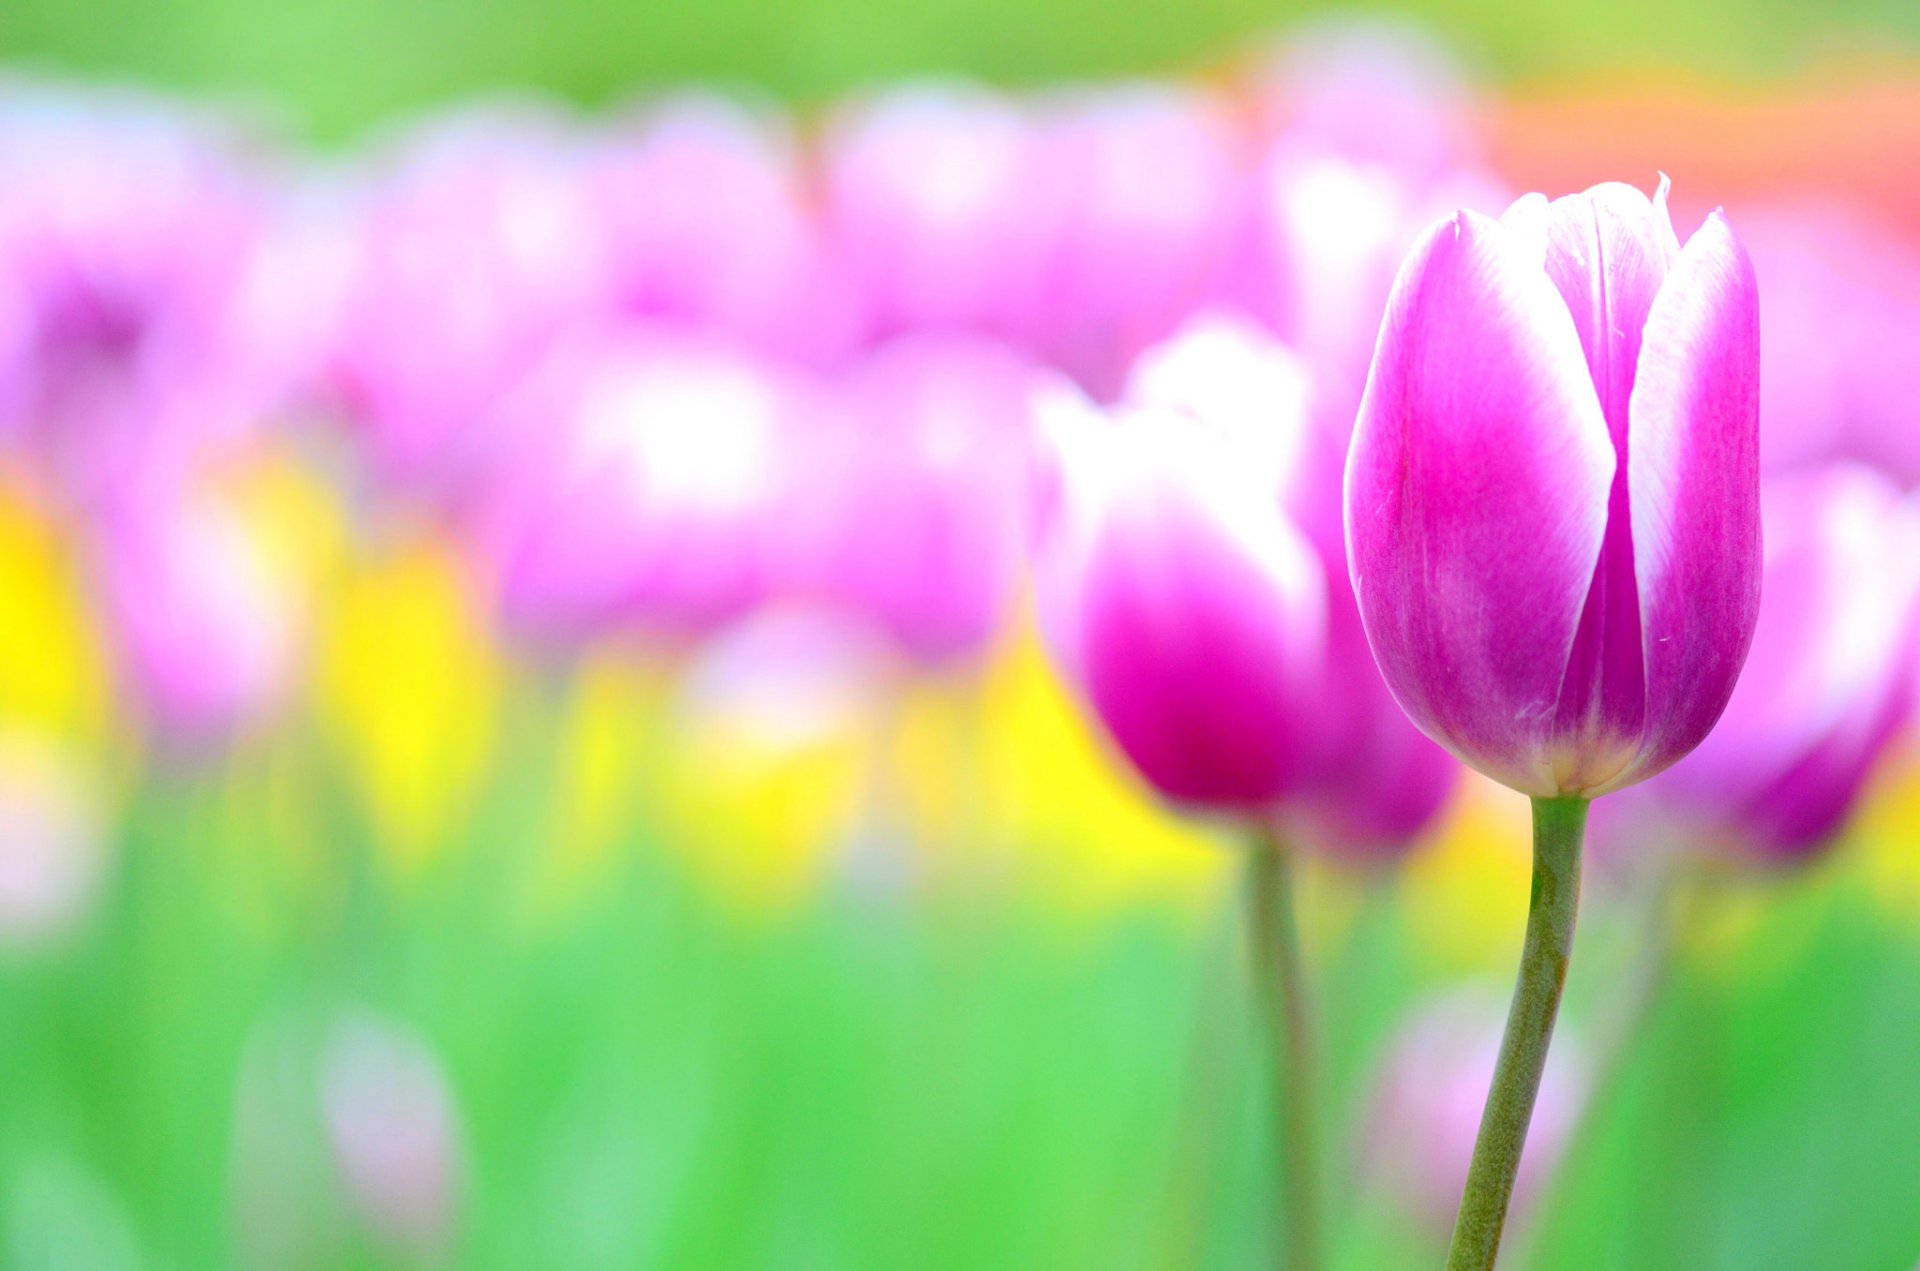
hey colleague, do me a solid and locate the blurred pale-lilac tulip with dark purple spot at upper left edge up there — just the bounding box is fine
[0,83,313,484]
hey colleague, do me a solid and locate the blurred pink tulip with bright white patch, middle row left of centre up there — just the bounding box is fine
[474,330,812,641]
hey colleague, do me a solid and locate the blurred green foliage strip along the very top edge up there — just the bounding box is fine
[0,0,1920,140]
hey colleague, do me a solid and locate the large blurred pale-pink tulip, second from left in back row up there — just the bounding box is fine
[334,113,609,490]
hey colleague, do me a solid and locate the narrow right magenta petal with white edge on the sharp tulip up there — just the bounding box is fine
[1613,211,1761,787]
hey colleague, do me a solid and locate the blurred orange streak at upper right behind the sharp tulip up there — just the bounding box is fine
[1484,58,1920,240]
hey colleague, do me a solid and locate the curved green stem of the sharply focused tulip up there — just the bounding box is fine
[1446,799,1586,1271]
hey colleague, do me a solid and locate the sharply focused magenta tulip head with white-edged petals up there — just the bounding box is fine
[1346,184,1761,799]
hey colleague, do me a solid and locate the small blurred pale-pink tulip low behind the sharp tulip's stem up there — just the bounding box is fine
[1361,989,1592,1236]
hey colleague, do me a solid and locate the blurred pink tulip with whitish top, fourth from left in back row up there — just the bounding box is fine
[824,83,1046,349]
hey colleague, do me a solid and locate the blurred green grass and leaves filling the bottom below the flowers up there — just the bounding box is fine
[0,737,1920,1271]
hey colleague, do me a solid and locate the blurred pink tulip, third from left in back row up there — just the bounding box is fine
[591,98,852,361]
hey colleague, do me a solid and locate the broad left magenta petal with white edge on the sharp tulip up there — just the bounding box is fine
[1346,213,1615,795]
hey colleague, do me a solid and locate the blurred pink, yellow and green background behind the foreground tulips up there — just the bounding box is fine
[0,0,1920,1271]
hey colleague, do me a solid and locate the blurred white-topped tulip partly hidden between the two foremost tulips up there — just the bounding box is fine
[1127,317,1455,856]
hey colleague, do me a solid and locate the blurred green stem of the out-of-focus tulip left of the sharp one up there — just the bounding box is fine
[1246,827,1319,1271]
